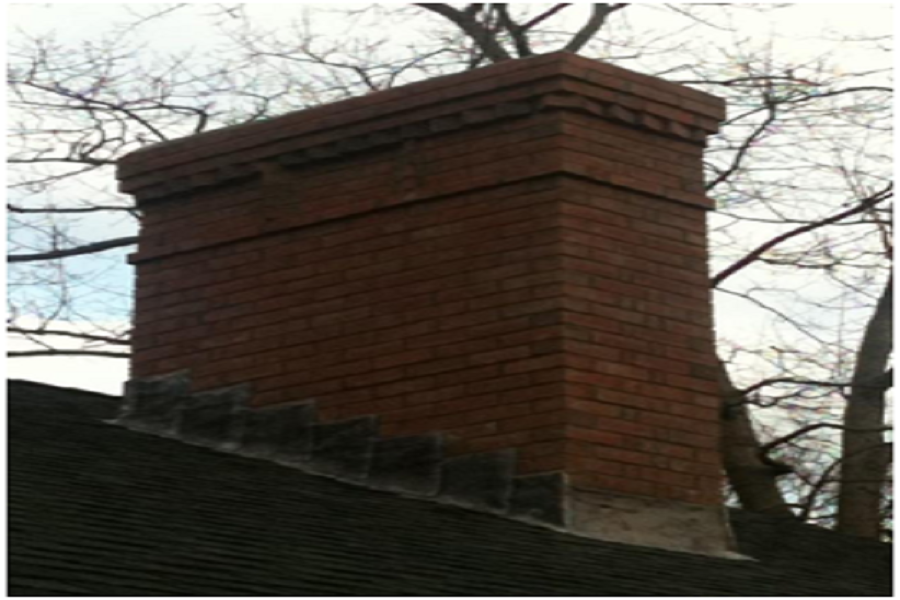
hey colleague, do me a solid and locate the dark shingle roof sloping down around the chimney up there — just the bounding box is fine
[9,381,892,596]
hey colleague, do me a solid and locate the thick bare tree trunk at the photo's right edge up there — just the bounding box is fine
[838,277,893,538]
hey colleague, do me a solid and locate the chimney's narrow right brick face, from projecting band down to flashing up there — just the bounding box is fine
[560,180,721,504]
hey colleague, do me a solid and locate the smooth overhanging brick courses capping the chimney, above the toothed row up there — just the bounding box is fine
[117,52,725,193]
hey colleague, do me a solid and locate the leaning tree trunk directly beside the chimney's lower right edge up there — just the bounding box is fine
[719,361,794,517]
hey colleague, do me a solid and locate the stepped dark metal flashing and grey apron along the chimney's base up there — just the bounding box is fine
[114,372,746,559]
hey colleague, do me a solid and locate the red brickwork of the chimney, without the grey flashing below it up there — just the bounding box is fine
[121,56,721,503]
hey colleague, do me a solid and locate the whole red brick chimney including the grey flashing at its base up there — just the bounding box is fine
[118,53,732,555]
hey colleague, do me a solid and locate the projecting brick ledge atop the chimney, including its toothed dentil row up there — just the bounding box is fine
[117,52,725,200]
